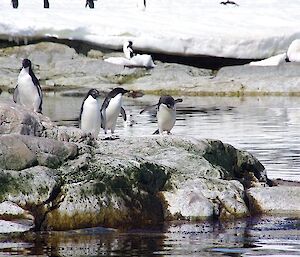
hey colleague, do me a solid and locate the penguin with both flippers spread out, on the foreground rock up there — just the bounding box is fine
[140,95,183,134]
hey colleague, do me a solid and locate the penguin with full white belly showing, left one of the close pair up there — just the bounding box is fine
[79,88,101,138]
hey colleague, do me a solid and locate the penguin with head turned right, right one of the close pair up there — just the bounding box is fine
[101,87,129,134]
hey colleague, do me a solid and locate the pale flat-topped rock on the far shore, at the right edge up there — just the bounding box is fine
[212,63,300,95]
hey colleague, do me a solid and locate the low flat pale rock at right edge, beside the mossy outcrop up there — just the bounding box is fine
[246,186,300,216]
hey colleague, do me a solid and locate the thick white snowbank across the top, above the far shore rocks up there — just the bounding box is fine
[0,0,300,59]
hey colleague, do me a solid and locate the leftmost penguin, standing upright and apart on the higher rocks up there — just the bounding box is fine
[13,59,43,113]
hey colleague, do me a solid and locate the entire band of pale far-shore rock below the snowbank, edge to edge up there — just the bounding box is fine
[0,42,300,95]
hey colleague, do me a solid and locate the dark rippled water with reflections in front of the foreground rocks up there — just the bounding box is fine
[0,217,300,254]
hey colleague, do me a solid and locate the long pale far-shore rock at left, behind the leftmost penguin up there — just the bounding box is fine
[0,42,211,94]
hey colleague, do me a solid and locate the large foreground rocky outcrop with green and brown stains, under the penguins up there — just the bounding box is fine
[0,104,298,230]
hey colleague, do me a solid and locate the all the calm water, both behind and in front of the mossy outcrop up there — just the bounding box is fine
[0,93,300,257]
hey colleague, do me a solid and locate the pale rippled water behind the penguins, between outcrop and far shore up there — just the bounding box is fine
[44,94,300,181]
